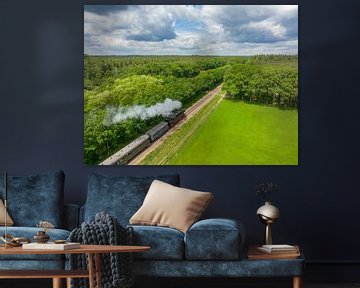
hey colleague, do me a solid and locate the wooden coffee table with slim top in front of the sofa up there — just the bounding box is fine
[0,245,150,288]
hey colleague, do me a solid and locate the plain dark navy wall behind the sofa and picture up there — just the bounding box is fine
[0,0,360,261]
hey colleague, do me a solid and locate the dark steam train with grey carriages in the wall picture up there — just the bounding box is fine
[99,109,185,165]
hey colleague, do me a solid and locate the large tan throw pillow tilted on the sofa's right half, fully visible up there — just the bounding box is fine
[130,180,213,233]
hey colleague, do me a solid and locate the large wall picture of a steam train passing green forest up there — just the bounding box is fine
[84,5,298,165]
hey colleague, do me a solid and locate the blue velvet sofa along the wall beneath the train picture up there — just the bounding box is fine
[0,171,303,287]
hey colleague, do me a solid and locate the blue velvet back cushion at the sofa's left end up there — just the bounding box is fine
[0,171,65,228]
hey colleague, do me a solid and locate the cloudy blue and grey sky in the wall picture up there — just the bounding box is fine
[84,5,298,55]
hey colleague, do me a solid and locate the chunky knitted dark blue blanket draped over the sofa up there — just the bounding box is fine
[68,212,134,288]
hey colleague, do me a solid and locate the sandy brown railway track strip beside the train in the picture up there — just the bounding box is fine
[128,84,222,165]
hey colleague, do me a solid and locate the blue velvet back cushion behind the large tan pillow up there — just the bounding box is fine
[84,174,180,226]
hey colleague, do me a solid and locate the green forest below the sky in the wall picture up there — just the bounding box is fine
[84,55,298,165]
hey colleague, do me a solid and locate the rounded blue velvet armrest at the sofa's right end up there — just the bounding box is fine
[185,218,245,260]
